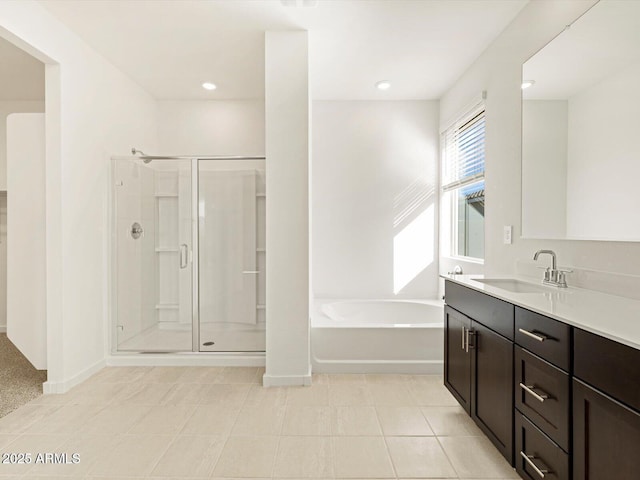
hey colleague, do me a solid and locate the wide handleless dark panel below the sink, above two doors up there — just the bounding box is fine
[444,280,513,340]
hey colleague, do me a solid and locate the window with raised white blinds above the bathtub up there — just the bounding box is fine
[441,103,485,260]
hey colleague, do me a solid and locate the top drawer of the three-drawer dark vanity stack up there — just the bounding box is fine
[515,307,571,371]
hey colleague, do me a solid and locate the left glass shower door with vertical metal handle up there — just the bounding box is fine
[113,157,195,352]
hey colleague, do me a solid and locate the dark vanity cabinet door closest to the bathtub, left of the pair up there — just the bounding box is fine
[444,307,471,413]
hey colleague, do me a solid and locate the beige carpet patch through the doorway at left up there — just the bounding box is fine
[0,333,47,417]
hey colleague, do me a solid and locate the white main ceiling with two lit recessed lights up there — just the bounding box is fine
[41,0,528,100]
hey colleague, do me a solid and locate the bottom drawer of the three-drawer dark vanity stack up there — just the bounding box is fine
[516,412,569,480]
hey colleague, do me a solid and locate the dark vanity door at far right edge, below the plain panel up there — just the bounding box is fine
[573,379,640,480]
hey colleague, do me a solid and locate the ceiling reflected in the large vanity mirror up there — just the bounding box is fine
[522,0,640,100]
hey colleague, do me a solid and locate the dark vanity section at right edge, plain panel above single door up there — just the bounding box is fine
[573,328,640,480]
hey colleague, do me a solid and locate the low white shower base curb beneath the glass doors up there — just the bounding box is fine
[107,353,265,367]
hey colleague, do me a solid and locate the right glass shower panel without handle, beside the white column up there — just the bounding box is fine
[197,159,266,352]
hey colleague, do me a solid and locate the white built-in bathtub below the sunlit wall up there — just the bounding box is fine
[311,299,444,374]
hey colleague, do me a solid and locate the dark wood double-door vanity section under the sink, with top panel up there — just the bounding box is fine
[445,282,513,464]
